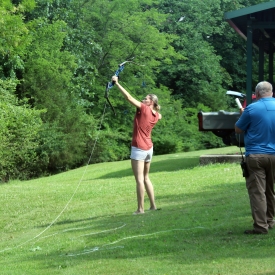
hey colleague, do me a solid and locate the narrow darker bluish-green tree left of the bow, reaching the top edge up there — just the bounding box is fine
[26,0,101,112]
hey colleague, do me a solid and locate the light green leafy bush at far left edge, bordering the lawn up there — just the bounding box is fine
[0,80,42,182]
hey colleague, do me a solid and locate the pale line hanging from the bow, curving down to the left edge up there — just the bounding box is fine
[0,102,110,253]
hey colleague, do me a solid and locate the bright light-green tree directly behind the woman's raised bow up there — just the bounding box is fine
[75,0,181,161]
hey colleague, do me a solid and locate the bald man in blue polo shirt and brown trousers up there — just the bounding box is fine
[235,81,275,234]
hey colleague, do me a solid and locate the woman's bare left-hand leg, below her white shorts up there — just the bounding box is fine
[131,159,145,214]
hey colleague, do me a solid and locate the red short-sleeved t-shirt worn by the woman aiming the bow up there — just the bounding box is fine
[132,103,159,150]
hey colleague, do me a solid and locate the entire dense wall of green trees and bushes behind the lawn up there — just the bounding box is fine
[0,0,264,181]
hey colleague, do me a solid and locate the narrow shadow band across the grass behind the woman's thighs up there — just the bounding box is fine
[95,157,199,180]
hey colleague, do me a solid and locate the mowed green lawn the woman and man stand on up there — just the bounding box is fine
[0,149,275,275]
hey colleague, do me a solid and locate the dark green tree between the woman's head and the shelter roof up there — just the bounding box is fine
[155,0,232,110]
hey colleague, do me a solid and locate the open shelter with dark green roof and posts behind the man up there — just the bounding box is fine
[224,1,275,104]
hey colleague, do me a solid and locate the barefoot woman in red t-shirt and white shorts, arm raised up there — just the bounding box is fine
[112,76,161,215]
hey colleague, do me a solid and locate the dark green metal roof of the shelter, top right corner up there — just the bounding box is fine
[224,1,275,53]
